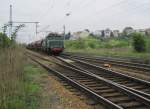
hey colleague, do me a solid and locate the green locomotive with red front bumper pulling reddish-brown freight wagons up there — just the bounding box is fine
[27,33,64,55]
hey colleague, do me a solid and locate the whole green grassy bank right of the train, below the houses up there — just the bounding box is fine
[65,37,150,59]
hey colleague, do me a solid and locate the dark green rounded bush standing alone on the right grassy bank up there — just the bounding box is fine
[131,33,146,52]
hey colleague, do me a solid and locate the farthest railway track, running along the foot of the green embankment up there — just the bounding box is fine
[63,54,150,72]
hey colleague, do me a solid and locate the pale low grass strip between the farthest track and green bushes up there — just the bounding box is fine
[65,48,150,60]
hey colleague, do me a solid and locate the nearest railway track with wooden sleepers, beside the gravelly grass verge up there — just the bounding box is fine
[26,51,150,109]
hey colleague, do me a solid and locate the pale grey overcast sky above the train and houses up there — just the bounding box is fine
[0,0,150,42]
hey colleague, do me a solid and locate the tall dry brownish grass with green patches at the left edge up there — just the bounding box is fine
[0,47,44,109]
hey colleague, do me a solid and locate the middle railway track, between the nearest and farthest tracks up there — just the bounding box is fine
[58,57,150,99]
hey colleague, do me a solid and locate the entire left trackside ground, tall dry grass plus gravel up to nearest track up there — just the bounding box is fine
[0,47,90,109]
